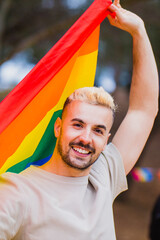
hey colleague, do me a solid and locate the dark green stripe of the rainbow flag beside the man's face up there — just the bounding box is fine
[7,110,62,173]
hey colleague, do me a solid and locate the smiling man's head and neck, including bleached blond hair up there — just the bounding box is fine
[41,87,115,177]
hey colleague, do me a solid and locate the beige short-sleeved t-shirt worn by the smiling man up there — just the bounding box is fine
[0,144,127,240]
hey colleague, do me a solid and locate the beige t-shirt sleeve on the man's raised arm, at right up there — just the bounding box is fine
[93,143,128,201]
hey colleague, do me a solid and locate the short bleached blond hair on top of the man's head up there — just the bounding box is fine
[62,87,116,116]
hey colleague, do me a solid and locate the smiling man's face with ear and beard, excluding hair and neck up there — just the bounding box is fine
[55,101,113,170]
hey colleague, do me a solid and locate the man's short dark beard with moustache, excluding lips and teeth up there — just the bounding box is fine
[57,137,100,171]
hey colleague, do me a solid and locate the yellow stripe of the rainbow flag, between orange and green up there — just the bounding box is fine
[0,51,98,174]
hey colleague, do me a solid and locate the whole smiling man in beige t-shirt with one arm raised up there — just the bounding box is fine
[0,0,158,240]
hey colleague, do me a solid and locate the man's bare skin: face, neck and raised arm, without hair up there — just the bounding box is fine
[41,0,159,177]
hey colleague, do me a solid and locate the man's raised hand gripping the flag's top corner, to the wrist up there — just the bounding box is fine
[108,0,145,36]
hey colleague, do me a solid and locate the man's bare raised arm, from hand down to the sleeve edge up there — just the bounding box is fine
[108,0,159,174]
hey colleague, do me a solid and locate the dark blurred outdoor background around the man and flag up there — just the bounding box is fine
[0,0,160,240]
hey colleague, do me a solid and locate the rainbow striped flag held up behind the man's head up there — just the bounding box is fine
[0,0,114,173]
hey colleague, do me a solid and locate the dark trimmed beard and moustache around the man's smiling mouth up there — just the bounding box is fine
[57,138,98,171]
